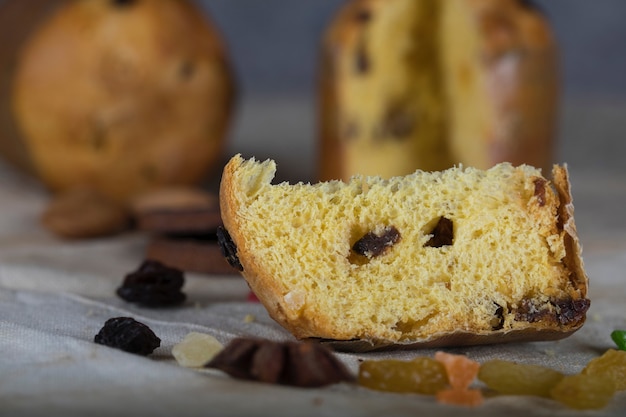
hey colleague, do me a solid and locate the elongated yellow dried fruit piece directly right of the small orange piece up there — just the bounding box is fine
[478,359,565,397]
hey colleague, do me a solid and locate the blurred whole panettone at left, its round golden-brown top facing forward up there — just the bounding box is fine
[0,0,234,201]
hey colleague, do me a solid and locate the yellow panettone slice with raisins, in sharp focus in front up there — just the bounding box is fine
[220,155,589,349]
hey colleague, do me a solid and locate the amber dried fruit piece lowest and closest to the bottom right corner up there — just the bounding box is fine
[550,374,615,410]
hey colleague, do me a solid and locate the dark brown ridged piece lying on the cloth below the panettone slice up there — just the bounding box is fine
[206,338,353,387]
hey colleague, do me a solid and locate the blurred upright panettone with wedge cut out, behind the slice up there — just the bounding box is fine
[319,0,558,180]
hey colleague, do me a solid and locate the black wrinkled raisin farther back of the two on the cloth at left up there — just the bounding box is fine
[116,260,186,307]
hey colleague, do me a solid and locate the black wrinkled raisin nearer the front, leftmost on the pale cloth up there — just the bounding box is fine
[94,317,161,356]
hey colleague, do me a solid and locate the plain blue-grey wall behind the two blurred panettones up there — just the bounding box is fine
[198,0,626,99]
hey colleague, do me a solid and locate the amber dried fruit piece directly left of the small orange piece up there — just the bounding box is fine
[358,356,448,395]
